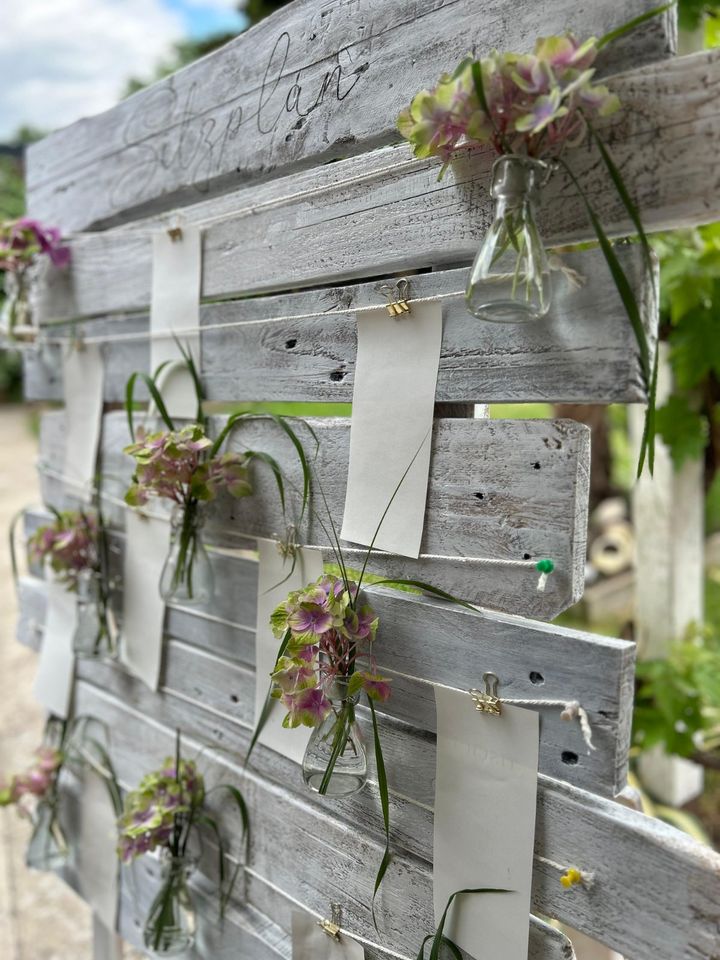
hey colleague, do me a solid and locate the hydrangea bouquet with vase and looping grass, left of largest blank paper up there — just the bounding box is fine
[124,351,316,605]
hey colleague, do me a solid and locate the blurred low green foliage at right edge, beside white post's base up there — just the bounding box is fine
[633,625,720,757]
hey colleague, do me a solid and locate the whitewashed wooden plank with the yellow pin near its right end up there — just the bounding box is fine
[49,667,720,960]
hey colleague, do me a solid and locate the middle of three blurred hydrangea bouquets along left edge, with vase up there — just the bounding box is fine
[28,510,117,657]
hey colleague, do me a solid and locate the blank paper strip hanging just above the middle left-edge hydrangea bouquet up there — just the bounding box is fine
[62,344,105,500]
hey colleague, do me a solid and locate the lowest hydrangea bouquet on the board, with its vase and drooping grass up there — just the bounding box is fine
[118,733,249,956]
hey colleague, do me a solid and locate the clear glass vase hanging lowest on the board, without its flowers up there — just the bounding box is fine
[143,856,197,957]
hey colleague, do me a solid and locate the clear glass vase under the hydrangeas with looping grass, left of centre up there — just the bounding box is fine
[160,500,214,606]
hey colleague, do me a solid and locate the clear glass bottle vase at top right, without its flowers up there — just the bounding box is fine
[465,154,551,323]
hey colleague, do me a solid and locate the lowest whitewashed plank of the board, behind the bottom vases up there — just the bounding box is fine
[62,768,573,960]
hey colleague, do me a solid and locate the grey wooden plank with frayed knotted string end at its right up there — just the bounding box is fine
[18,555,634,796]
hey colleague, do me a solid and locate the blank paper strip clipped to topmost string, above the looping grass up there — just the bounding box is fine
[150,225,202,420]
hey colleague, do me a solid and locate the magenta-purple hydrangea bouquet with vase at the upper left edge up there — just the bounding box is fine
[0,217,70,340]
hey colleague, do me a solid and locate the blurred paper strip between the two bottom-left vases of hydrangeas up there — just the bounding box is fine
[75,769,119,930]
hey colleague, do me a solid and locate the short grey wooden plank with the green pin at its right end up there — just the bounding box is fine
[36,411,589,620]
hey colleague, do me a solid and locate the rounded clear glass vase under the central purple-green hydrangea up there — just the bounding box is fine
[302,677,367,797]
